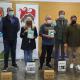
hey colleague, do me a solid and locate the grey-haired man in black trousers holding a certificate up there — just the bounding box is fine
[39,16,54,69]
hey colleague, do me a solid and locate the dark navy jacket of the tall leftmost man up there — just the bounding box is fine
[2,15,20,40]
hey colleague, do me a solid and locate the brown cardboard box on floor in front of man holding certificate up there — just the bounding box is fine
[44,70,55,80]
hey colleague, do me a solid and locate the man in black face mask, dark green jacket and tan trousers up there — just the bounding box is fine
[64,15,80,71]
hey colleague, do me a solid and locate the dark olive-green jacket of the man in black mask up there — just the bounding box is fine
[65,24,80,47]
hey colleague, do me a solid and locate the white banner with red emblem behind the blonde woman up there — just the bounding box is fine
[16,4,39,59]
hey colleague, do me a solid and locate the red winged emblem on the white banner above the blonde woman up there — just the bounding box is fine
[19,7,36,22]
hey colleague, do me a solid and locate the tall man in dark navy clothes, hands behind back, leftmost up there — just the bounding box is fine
[2,8,20,71]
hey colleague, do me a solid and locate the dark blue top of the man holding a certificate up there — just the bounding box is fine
[39,24,54,45]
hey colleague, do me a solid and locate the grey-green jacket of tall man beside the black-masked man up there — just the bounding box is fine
[54,18,68,41]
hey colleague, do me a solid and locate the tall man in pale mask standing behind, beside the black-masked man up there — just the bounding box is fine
[54,10,68,69]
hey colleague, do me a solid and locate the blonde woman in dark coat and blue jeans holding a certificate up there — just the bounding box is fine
[20,17,38,64]
